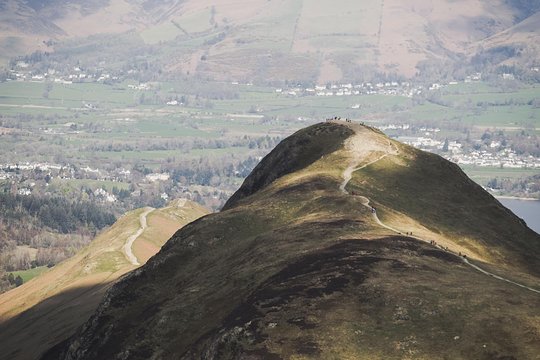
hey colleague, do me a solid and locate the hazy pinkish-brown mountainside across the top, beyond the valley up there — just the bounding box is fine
[0,0,540,79]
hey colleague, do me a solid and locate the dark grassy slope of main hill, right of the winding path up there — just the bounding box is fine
[349,134,540,275]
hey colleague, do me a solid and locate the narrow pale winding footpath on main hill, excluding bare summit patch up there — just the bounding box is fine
[339,128,540,294]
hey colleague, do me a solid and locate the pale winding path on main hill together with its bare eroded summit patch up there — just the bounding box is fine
[339,124,540,294]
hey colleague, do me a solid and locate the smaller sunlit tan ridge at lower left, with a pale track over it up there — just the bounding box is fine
[0,200,208,360]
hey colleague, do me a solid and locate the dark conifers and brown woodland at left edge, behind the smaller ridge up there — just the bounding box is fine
[0,193,116,292]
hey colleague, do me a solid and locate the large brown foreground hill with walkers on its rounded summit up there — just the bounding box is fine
[43,122,540,360]
